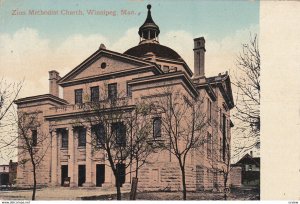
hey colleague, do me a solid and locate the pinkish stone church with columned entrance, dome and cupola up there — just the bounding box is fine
[15,5,234,193]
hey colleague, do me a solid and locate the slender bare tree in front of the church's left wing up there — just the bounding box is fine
[17,111,50,200]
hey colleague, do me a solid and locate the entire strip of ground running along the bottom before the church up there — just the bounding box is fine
[0,187,259,200]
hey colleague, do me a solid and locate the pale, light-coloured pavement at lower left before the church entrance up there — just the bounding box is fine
[0,187,129,200]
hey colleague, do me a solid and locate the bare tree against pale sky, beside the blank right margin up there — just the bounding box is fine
[233,35,260,155]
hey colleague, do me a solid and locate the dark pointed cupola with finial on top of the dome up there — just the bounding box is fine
[139,4,160,43]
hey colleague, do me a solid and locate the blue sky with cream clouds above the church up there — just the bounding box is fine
[0,0,259,163]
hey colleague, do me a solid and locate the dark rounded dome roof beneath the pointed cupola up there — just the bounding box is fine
[124,43,184,62]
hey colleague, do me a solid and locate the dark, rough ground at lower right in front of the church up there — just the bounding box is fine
[82,189,260,200]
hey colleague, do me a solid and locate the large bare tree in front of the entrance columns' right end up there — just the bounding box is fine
[76,87,152,200]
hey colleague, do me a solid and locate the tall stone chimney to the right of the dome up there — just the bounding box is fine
[194,37,206,77]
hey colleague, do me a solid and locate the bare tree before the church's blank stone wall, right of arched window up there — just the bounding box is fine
[146,88,206,200]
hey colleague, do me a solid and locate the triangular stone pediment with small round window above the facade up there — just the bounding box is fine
[59,50,155,84]
